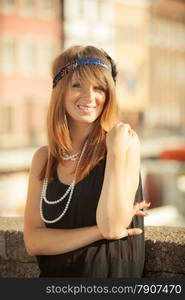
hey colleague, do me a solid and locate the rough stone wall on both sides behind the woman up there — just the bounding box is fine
[0,217,185,278]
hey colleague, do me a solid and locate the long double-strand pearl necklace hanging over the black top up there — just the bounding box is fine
[40,141,87,223]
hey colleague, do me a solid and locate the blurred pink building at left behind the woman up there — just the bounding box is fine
[0,0,62,149]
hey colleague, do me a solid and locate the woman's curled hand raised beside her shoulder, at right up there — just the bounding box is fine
[106,122,136,157]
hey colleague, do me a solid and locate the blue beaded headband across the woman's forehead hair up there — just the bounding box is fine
[53,57,111,88]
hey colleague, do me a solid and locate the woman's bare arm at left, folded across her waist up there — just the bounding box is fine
[24,147,104,255]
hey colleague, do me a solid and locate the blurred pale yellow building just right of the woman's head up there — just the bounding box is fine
[115,0,150,127]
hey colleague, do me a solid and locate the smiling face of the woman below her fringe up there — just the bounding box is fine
[64,74,106,124]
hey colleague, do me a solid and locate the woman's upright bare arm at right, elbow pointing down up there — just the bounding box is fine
[96,128,140,239]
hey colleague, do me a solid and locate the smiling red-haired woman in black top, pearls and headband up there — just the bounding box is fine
[24,46,148,278]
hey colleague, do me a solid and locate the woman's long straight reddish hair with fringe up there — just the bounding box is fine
[40,46,118,181]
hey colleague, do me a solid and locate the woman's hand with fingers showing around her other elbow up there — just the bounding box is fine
[105,200,151,240]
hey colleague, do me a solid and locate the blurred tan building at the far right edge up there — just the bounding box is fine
[145,0,185,133]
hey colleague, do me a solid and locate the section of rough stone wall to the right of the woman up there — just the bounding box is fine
[145,226,185,278]
